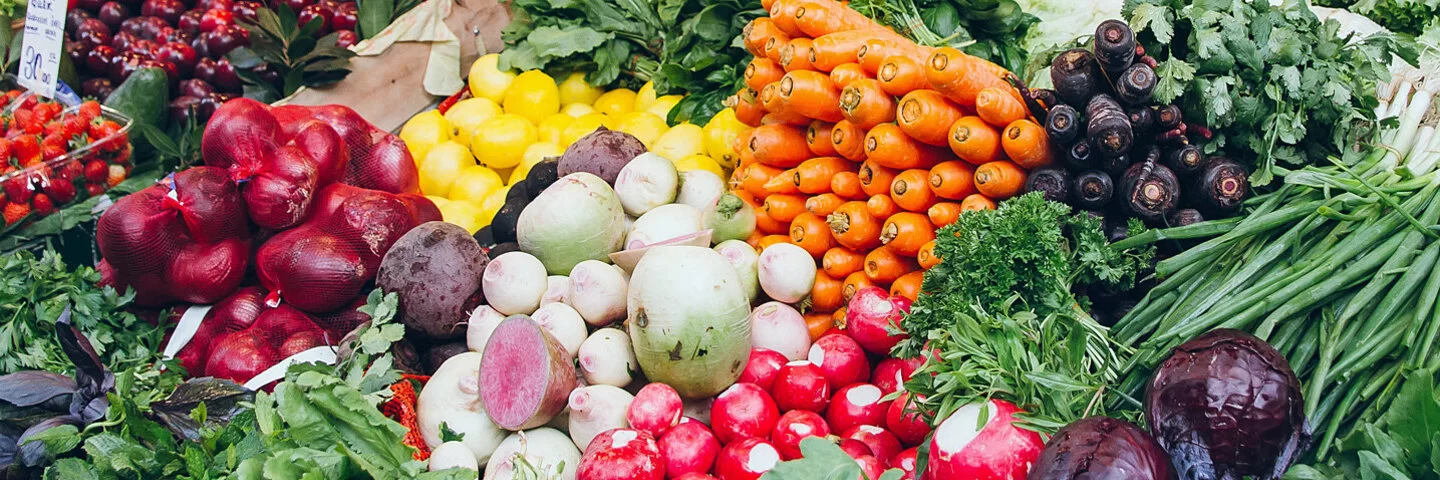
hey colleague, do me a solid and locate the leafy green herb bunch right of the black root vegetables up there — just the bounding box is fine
[1123,0,1414,185]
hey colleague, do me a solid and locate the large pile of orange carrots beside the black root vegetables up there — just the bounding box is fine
[730,0,1056,337]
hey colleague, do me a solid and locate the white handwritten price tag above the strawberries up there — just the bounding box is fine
[20,0,66,98]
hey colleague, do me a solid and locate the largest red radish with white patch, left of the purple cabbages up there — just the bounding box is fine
[924,399,1045,480]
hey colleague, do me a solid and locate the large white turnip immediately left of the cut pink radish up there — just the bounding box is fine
[415,352,505,464]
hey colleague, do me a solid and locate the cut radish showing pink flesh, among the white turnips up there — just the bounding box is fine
[480,316,575,431]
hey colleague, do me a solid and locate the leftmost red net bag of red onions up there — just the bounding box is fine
[95,167,251,307]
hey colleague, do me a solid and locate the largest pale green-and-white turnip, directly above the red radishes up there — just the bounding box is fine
[625,246,750,398]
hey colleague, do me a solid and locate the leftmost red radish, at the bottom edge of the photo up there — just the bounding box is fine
[577,428,665,480]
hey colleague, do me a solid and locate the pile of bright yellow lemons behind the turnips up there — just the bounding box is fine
[400,53,746,232]
